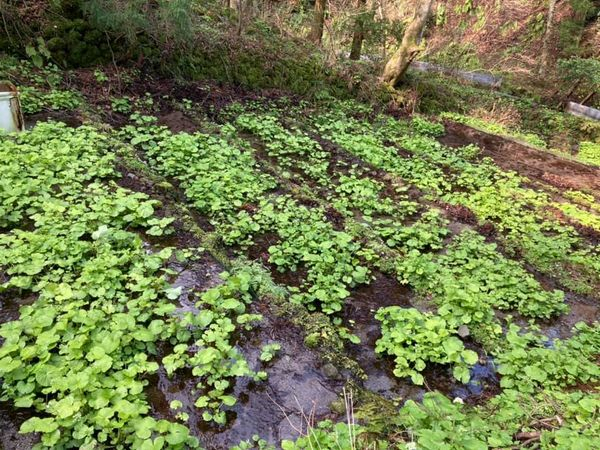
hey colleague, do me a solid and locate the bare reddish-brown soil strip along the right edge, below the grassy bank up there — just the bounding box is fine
[440,121,600,198]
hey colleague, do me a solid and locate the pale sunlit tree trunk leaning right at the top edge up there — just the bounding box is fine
[382,0,434,87]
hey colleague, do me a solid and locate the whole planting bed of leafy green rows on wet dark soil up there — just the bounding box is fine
[0,61,600,449]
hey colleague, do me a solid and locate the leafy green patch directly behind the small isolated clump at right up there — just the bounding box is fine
[396,231,567,345]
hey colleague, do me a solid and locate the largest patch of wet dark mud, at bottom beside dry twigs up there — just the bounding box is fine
[147,302,343,450]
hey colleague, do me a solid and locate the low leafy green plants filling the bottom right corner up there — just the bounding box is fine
[396,390,600,450]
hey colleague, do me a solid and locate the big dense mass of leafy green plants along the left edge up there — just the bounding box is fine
[0,124,266,448]
